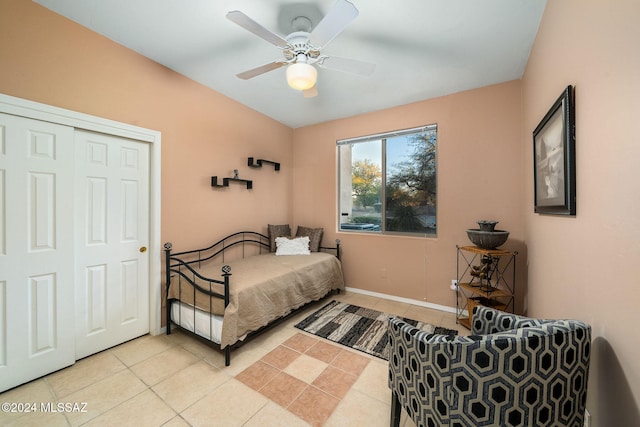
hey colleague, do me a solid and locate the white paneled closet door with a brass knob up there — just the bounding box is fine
[75,131,149,359]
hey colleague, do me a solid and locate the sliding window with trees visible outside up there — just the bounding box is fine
[337,125,437,236]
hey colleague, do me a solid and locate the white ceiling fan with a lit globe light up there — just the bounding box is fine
[227,0,376,98]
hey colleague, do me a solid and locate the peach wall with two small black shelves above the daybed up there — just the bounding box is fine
[0,0,293,249]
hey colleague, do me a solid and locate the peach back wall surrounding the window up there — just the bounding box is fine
[293,81,524,307]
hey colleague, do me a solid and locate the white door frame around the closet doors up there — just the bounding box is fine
[0,94,162,335]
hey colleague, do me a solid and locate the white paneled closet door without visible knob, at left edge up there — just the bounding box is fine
[0,114,75,391]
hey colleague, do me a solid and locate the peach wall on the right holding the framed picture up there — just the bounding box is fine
[522,0,640,426]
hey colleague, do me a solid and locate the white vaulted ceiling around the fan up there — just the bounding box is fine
[34,0,546,128]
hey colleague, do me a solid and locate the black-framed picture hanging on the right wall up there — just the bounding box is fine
[533,86,576,215]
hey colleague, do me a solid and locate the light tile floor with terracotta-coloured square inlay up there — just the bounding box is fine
[0,292,468,427]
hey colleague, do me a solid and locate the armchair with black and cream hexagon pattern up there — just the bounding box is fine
[389,306,591,427]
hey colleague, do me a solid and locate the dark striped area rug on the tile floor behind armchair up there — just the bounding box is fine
[295,301,458,360]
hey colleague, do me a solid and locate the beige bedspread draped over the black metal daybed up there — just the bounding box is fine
[169,252,344,348]
